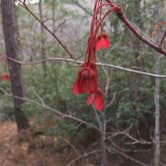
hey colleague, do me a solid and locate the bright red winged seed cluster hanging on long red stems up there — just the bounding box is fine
[73,0,121,110]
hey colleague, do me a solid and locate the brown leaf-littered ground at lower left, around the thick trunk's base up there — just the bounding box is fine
[0,122,93,166]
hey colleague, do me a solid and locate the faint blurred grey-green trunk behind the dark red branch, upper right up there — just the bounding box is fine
[128,0,143,107]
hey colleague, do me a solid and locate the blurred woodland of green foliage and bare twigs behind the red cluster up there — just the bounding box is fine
[0,0,166,166]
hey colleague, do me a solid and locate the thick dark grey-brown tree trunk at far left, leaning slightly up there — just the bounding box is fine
[1,0,29,131]
